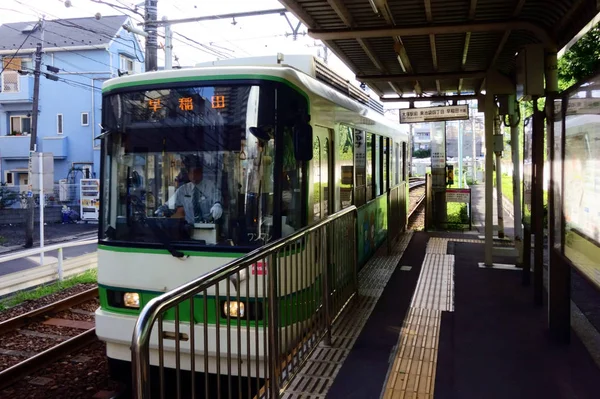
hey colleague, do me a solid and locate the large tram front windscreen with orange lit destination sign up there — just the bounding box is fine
[101,86,282,247]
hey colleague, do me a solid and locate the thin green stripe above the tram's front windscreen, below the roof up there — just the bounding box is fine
[102,74,309,101]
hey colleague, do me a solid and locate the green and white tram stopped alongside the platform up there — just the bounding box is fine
[96,56,408,382]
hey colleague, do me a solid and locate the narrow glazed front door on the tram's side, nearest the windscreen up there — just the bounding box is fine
[312,126,334,221]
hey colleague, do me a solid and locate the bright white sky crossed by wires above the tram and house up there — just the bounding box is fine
[0,0,354,80]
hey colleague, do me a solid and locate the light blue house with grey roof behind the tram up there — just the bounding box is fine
[0,15,144,191]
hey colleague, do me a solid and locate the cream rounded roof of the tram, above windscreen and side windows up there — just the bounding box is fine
[102,64,406,137]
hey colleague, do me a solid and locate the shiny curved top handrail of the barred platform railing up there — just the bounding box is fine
[131,205,358,398]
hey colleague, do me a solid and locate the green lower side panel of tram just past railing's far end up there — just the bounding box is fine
[358,196,387,265]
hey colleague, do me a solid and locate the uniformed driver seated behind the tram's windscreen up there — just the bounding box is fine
[172,156,223,225]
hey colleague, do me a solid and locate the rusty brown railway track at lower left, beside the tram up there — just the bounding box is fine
[0,288,98,389]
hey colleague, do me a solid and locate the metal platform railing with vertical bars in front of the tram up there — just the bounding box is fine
[131,206,358,398]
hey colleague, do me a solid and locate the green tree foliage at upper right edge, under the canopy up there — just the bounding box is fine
[558,25,600,90]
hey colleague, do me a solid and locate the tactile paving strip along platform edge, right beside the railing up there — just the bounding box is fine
[283,232,412,399]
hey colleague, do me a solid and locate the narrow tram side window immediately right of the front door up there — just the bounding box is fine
[335,125,354,209]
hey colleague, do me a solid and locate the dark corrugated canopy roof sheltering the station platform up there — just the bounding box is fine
[280,0,600,101]
